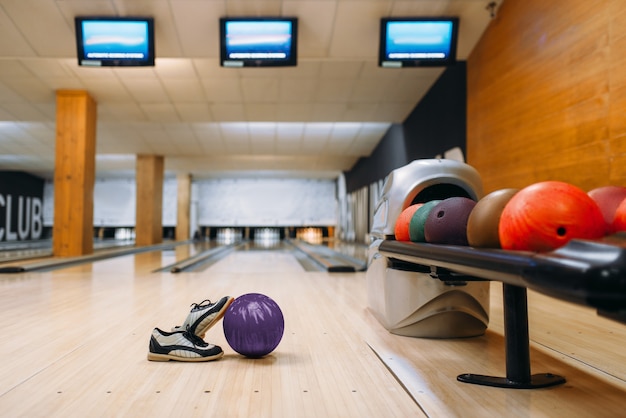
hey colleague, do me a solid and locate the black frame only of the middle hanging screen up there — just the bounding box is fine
[219,17,298,68]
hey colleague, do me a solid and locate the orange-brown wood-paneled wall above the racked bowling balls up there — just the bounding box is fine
[467,0,626,192]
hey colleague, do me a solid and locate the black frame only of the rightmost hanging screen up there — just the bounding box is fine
[378,16,459,68]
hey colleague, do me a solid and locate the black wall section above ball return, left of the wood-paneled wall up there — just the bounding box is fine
[344,61,467,193]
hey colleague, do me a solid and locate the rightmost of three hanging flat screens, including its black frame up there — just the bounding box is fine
[378,17,459,67]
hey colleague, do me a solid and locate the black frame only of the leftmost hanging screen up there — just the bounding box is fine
[74,16,155,67]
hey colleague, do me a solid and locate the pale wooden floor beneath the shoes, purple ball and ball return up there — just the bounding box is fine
[0,243,626,417]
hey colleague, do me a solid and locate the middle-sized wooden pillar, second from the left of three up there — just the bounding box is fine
[135,155,164,246]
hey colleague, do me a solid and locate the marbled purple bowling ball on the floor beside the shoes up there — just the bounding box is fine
[223,293,285,358]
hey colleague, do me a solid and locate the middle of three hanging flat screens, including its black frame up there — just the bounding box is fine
[220,17,298,67]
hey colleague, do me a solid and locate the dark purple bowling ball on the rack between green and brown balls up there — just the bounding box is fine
[424,197,476,245]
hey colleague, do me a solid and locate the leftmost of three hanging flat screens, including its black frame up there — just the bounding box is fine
[75,17,154,67]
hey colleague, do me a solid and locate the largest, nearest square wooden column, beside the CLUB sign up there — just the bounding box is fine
[52,90,96,257]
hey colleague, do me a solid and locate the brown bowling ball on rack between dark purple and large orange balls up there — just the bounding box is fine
[467,189,519,248]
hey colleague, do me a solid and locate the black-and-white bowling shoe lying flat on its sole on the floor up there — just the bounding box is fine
[148,328,224,361]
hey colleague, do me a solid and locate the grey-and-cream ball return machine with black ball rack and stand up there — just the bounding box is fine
[366,159,626,389]
